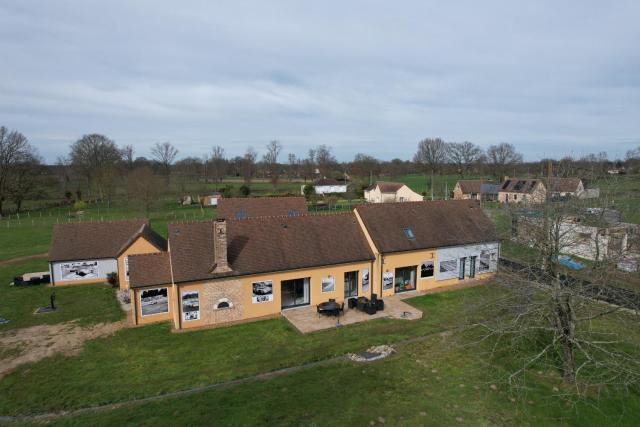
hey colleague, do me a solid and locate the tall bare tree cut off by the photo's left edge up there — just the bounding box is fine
[0,126,37,216]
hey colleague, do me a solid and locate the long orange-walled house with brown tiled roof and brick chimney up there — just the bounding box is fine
[122,200,499,329]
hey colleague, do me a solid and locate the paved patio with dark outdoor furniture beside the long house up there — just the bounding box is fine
[282,292,422,334]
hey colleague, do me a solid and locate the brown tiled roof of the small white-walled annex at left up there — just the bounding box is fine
[49,219,166,261]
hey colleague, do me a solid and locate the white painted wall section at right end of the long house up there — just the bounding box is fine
[436,242,500,280]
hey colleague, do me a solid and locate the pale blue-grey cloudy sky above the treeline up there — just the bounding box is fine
[0,0,640,162]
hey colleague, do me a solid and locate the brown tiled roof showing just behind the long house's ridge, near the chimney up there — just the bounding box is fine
[218,197,308,219]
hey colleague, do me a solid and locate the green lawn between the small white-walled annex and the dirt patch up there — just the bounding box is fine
[0,260,124,333]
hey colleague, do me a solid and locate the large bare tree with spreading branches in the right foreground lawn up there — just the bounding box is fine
[473,184,640,393]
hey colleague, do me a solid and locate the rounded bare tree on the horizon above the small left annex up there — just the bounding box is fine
[70,134,122,199]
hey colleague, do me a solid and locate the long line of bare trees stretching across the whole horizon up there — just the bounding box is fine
[0,127,640,217]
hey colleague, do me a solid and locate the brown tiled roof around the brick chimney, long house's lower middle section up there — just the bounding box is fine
[169,212,373,282]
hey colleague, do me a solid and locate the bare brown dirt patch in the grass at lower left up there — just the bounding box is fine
[0,320,127,378]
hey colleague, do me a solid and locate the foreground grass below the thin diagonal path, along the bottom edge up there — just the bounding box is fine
[27,328,640,426]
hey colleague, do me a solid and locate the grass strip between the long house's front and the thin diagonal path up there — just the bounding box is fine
[0,286,499,415]
